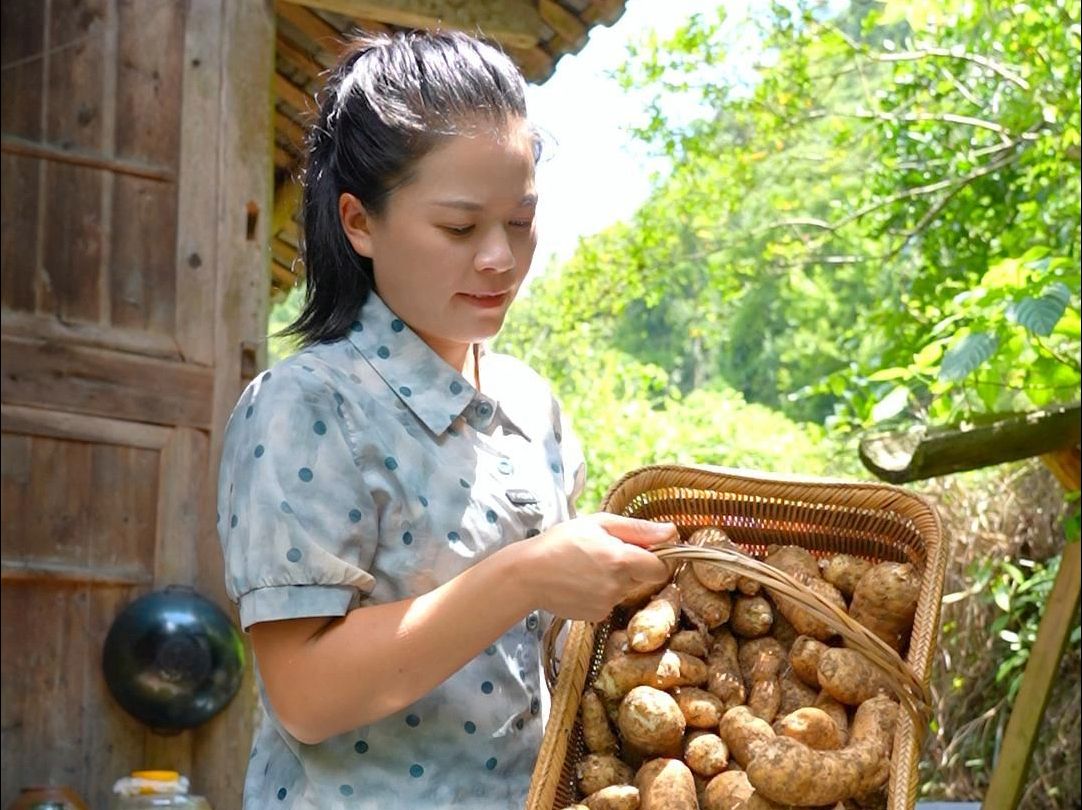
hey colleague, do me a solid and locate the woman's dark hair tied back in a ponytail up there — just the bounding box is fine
[283,31,526,345]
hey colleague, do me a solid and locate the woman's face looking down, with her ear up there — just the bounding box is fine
[342,122,537,364]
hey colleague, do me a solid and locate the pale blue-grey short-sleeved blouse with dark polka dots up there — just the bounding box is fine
[217,294,584,810]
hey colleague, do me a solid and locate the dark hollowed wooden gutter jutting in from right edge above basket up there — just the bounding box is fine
[860,403,1082,483]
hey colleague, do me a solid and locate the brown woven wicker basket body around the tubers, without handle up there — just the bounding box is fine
[526,466,947,810]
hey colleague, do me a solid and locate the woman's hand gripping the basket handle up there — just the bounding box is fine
[507,513,679,622]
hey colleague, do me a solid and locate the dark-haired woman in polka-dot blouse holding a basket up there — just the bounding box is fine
[219,32,676,810]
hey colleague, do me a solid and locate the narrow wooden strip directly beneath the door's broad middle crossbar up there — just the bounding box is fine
[0,403,173,450]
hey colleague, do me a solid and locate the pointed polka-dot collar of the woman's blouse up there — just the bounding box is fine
[349,292,525,436]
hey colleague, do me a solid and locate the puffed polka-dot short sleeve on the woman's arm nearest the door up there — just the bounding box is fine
[217,366,378,629]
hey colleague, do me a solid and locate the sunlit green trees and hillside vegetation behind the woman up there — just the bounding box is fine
[272,0,1082,795]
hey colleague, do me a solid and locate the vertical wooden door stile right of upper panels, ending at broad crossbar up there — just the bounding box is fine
[174,0,223,364]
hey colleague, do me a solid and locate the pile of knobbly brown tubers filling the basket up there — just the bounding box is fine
[567,527,921,810]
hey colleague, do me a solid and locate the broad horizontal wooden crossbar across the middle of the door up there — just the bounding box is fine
[2,335,213,429]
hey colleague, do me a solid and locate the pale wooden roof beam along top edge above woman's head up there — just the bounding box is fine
[285,0,544,48]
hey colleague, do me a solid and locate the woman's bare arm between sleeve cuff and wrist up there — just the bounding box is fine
[251,545,536,743]
